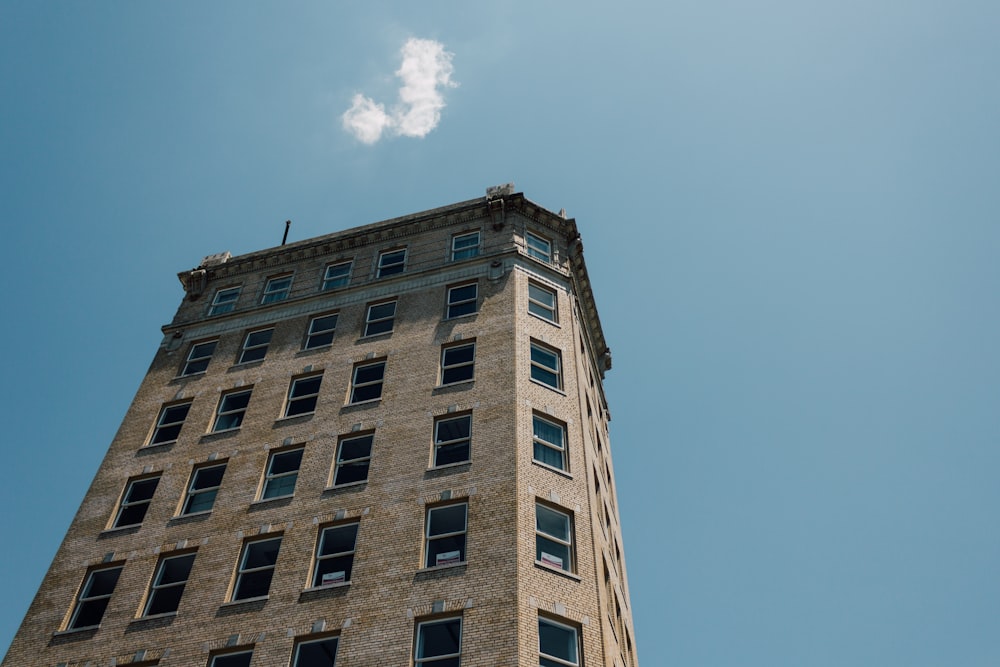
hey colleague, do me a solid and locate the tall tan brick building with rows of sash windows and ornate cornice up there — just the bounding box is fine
[3,186,637,667]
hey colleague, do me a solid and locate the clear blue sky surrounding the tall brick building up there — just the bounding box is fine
[0,0,1000,667]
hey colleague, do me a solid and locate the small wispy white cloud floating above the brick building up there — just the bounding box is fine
[341,38,458,144]
